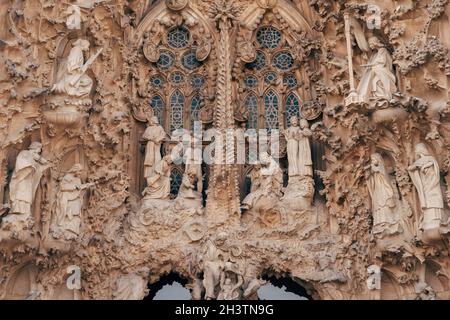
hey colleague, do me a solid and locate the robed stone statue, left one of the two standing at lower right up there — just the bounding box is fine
[367,153,402,235]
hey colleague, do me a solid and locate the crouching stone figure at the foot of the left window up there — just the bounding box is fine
[143,155,173,200]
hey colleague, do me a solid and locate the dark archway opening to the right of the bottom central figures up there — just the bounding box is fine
[258,275,313,300]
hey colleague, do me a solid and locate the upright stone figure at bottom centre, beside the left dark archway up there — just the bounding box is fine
[203,241,225,300]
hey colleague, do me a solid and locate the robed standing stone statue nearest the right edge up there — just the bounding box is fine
[408,143,444,230]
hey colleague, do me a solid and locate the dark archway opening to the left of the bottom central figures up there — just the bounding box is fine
[144,272,190,300]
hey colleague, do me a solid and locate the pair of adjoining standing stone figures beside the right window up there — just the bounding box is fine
[284,116,313,177]
